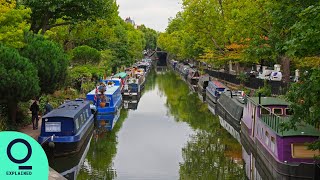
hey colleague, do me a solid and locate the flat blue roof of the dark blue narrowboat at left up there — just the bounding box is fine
[42,100,90,119]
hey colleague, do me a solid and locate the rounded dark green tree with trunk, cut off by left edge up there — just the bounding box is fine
[0,44,40,123]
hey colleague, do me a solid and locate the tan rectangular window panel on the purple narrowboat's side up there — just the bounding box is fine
[291,143,320,158]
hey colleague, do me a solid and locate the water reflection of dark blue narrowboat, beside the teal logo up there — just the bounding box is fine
[48,131,92,180]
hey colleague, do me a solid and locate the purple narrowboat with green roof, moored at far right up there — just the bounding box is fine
[241,97,320,179]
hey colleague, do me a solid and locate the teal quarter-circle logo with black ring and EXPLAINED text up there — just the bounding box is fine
[0,131,49,180]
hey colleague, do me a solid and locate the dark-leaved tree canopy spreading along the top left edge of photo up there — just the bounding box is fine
[21,0,118,34]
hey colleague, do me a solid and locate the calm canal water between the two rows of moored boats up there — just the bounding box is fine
[76,72,244,180]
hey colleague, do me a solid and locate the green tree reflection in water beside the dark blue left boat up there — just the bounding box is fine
[77,109,128,179]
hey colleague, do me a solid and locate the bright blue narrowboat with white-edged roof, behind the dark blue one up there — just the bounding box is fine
[87,79,122,131]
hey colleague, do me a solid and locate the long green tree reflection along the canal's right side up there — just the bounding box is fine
[157,72,243,179]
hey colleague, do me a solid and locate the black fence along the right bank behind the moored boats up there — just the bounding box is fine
[205,70,288,95]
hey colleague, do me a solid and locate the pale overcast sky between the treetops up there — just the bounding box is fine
[117,0,182,32]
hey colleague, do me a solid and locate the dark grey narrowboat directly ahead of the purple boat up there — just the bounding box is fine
[215,91,245,143]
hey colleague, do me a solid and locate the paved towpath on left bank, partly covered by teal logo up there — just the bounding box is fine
[19,117,66,180]
